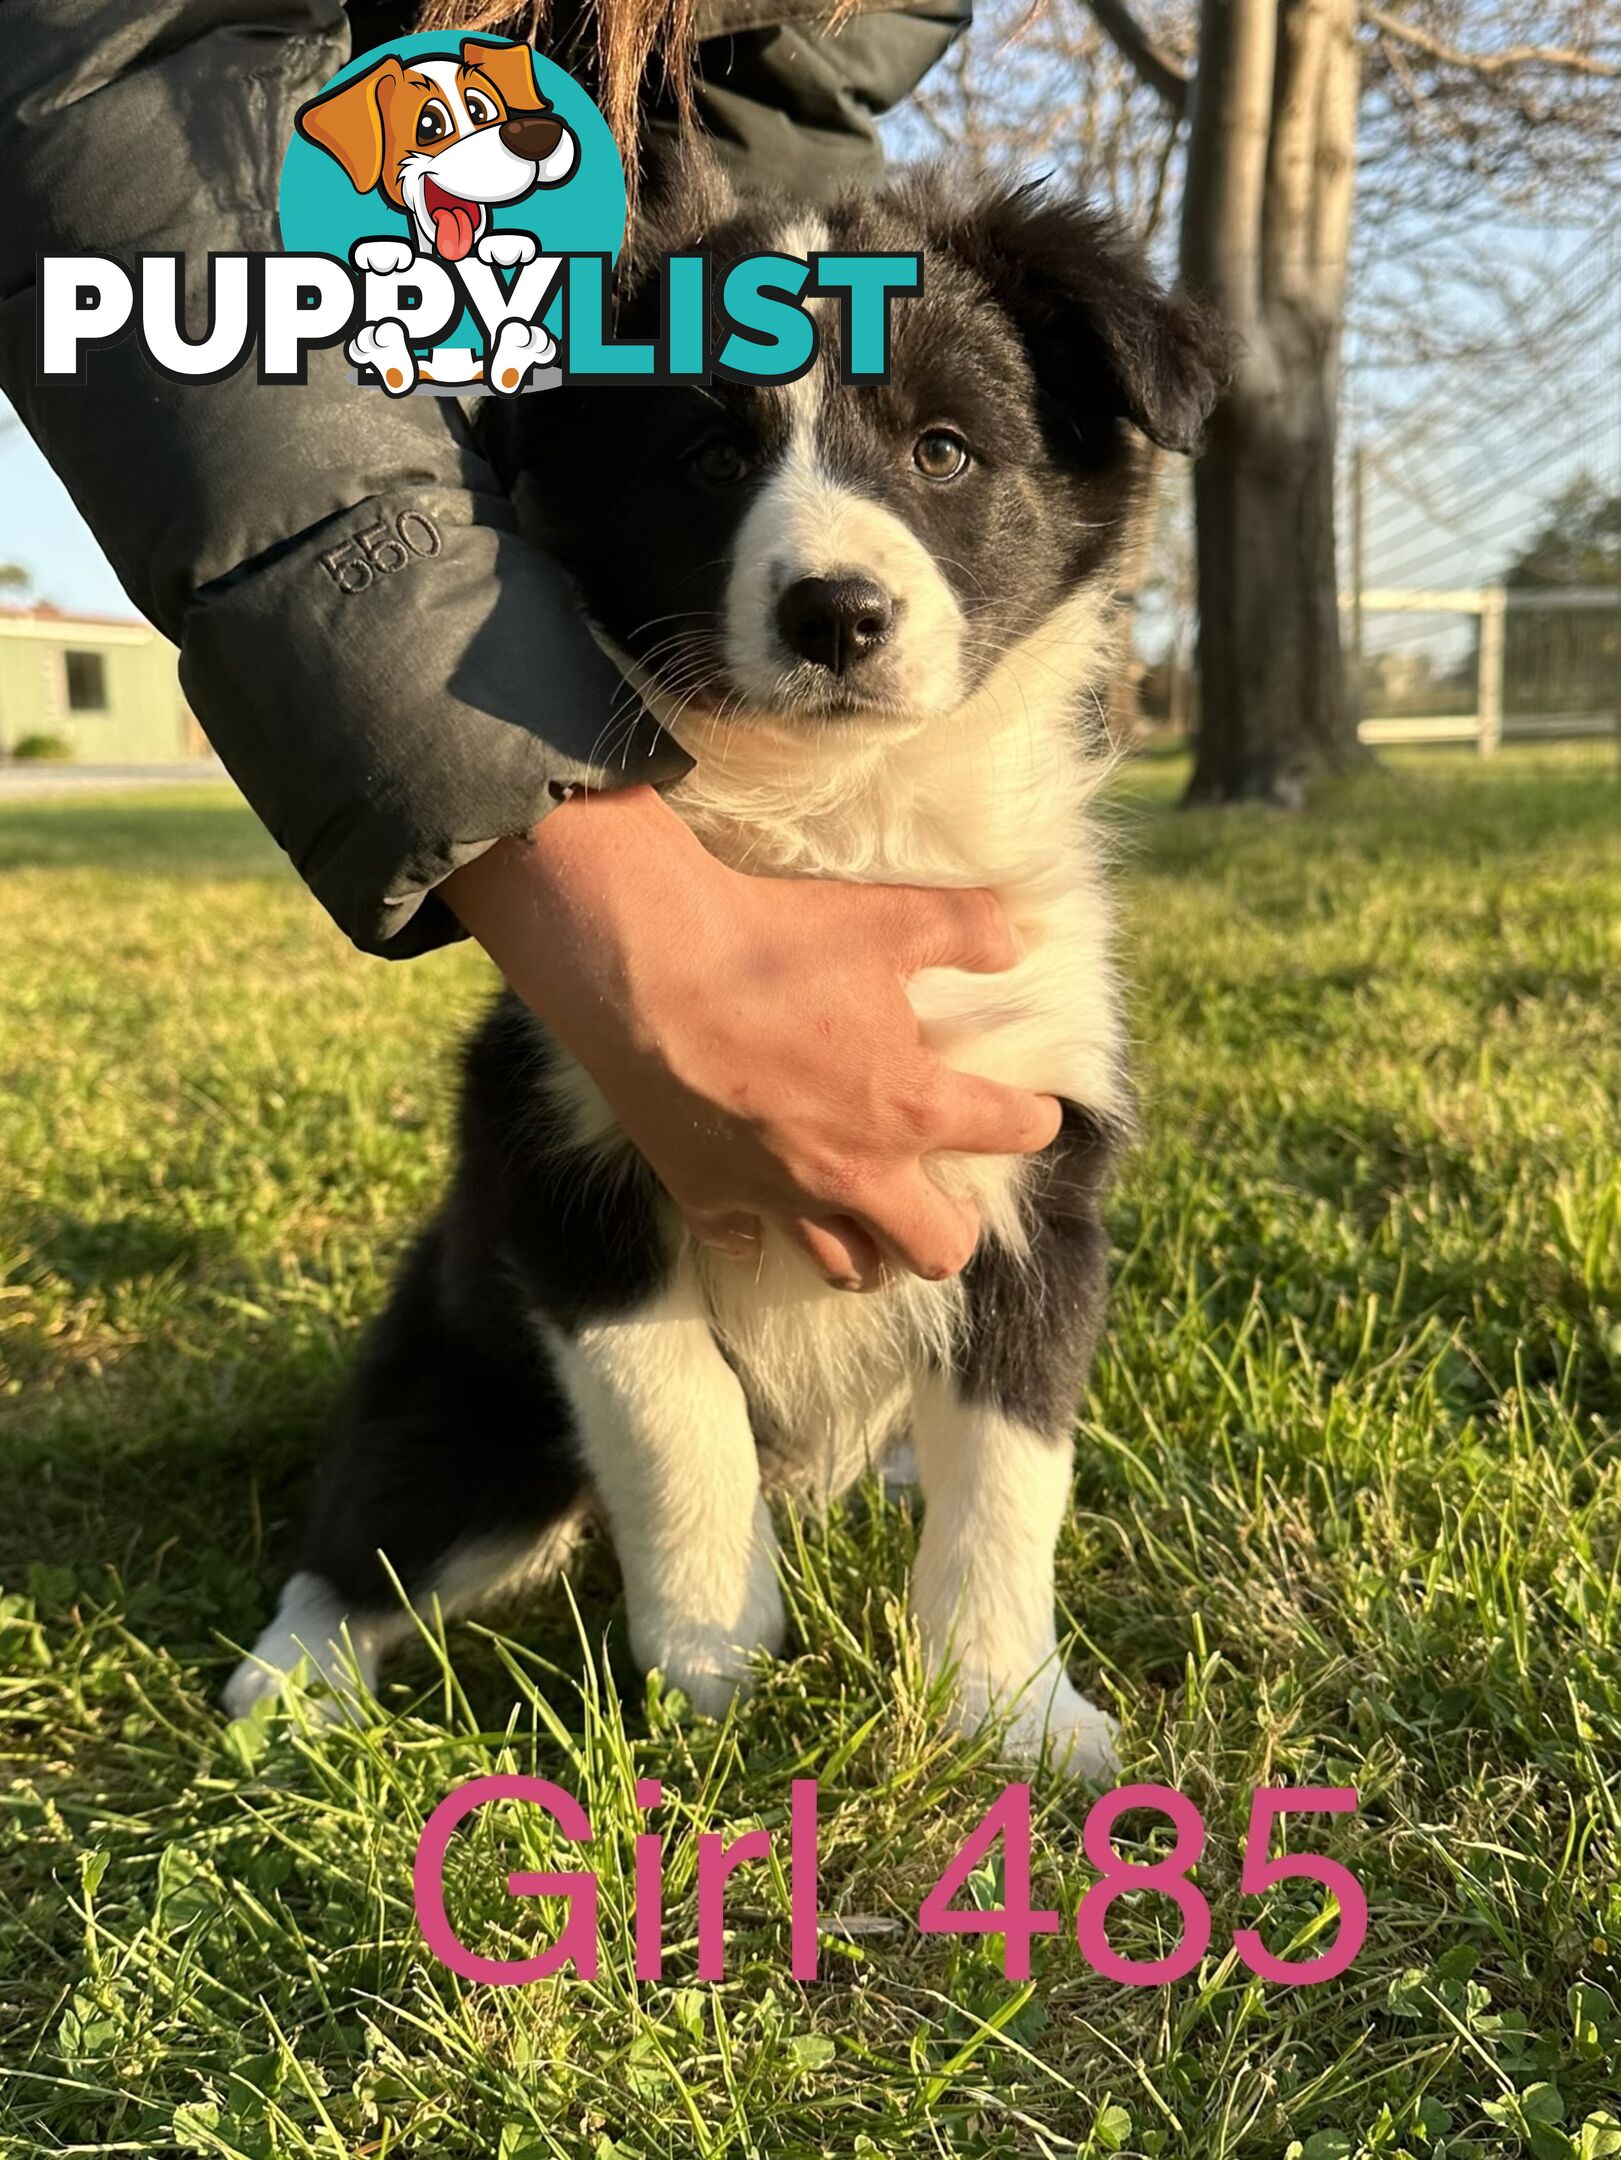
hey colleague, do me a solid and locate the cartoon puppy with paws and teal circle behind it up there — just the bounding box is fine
[279,32,625,395]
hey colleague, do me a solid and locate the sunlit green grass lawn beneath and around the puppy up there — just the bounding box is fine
[0,750,1621,2160]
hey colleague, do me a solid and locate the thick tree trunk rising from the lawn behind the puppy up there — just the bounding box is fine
[1182,0,1359,806]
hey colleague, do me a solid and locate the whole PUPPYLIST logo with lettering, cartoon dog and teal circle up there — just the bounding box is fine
[39,35,923,397]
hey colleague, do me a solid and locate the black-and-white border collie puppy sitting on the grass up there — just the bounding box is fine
[227,156,1225,1776]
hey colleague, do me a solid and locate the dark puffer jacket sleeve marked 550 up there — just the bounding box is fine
[0,0,689,957]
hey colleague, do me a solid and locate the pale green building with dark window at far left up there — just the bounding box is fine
[0,605,207,765]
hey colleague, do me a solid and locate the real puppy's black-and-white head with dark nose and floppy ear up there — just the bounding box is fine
[488,181,1223,732]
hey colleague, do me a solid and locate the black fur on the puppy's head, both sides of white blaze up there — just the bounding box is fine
[480,162,1228,725]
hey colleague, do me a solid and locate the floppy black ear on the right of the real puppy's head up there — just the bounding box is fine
[951,181,1234,451]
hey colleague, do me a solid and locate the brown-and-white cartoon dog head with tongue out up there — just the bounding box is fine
[298,37,579,261]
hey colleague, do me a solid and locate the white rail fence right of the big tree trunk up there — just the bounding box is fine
[1344,585,1621,758]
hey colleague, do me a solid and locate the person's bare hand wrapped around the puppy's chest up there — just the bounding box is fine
[443,788,1059,1290]
